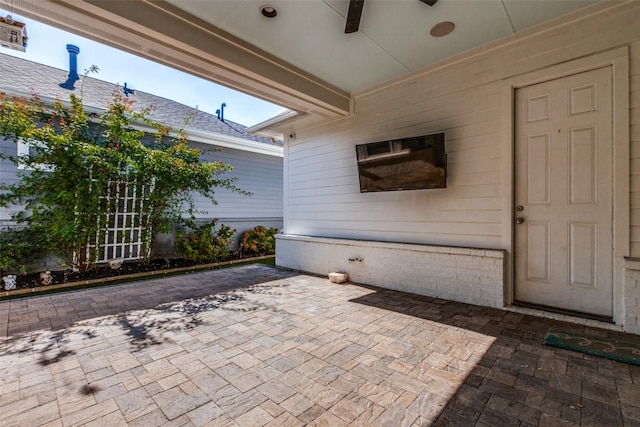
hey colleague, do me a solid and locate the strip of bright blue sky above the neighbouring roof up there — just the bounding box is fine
[0,9,285,126]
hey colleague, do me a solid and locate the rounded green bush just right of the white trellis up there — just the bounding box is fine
[176,219,237,262]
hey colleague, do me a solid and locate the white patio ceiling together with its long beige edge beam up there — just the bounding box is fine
[12,0,604,132]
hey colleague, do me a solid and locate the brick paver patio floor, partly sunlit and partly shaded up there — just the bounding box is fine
[0,265,640,427]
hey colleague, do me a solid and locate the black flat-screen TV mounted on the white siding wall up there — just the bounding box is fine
[356,133,447,193]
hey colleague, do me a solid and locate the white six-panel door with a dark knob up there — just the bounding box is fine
[514,67,613,317]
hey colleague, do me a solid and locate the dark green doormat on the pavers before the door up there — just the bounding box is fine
[543,328,640,366]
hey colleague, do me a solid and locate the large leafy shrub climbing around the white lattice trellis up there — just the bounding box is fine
[0,92,249,270]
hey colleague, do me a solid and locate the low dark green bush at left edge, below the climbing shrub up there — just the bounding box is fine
[0,228,44,276]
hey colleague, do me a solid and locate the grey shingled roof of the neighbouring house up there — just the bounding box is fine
[0,53,282,146]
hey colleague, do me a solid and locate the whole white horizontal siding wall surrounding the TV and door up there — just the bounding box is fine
[278,1,640,332]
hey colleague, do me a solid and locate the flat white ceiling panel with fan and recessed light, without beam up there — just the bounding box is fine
[167,0,597,93]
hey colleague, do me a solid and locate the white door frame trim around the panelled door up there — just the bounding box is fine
[500,46,630,324]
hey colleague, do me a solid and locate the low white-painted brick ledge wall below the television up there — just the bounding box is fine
[276,234,505,308]
